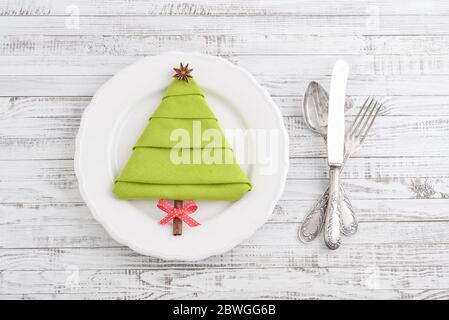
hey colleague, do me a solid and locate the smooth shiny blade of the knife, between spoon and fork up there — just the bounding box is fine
[327,60,349,166]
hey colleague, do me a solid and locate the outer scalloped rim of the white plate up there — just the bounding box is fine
[73,51,290,261]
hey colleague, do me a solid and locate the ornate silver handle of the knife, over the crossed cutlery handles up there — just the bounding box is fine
[324,166,341,250]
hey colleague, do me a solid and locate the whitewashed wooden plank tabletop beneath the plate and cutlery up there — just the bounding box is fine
[0,0,449,299]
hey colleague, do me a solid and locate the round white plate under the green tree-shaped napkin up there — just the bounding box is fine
[75,52,288,260]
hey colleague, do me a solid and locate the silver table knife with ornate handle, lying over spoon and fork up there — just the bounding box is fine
[324,60,349,249]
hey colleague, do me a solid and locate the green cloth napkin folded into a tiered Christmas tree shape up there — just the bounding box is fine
[113,79,251,201]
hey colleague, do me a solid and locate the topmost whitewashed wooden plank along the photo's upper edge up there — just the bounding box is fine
[0,0,449,16]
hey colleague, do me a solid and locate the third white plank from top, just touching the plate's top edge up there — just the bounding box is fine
[0,33,449,57]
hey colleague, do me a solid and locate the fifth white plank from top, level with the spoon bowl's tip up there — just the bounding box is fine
[0,72,449,97]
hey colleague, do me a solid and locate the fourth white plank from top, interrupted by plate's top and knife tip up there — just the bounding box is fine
[0,55,372,76]
